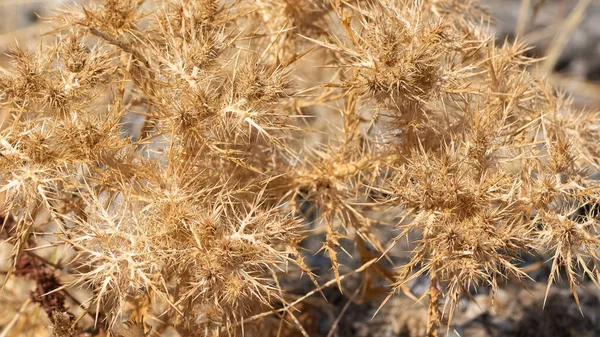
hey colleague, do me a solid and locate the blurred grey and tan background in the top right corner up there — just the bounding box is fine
[481,0,600,109]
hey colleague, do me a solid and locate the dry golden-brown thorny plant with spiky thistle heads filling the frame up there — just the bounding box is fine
[0,0,600,337]
